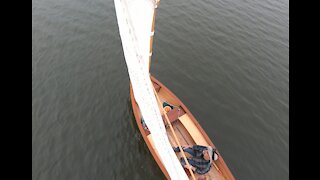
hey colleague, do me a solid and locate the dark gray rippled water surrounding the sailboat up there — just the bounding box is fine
[32,0,289,180]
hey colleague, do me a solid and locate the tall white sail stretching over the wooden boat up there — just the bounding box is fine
[114,0,188,180]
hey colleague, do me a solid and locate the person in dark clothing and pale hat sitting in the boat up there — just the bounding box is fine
[173,145,219,174]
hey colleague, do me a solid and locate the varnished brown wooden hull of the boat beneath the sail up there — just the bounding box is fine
[130,76,235,180]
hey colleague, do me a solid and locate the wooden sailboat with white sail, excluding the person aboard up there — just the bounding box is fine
[114,0,235,180]
